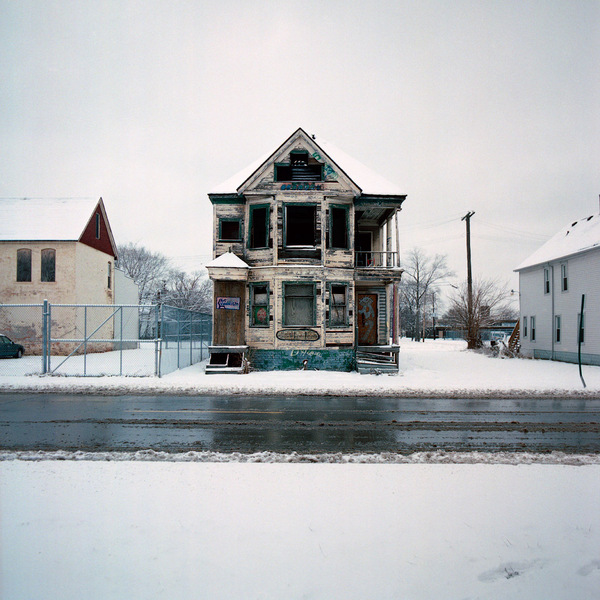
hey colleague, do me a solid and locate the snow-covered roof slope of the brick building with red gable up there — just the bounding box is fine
[0,198,98,241]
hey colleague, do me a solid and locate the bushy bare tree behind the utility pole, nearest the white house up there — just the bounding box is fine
[445,279,515,349]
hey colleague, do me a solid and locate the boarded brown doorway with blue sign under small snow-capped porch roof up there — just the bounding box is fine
[213,281,246,346]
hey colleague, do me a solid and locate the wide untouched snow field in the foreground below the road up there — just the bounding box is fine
[0,460,600,600]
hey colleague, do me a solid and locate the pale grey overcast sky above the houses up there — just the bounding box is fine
[0,0,600,296]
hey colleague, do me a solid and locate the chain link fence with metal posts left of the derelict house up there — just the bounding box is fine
[0,302,212,377]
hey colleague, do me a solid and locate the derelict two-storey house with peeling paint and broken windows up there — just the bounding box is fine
[206,129,406,373]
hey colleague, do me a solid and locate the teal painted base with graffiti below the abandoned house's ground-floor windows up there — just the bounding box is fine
[249,348,356,371]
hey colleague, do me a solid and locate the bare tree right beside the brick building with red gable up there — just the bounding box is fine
[117,243,172,304]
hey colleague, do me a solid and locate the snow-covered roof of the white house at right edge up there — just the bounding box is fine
[515,215,600,271]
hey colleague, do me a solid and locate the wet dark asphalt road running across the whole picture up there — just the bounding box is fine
[0,394,600,453]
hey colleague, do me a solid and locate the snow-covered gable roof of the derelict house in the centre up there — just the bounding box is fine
[209,127,405,196]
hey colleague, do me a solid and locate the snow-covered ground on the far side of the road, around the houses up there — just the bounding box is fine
[0,339,600,396]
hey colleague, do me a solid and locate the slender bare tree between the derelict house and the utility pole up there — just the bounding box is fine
[400,248,454,340]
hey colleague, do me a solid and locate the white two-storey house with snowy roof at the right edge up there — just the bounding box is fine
[515,215,600,365]
